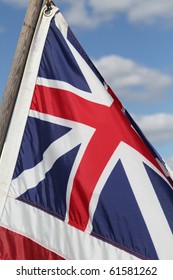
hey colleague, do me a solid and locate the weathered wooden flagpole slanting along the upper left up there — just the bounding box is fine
[0,0,44,154]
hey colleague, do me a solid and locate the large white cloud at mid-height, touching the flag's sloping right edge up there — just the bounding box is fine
[94,55,173,101]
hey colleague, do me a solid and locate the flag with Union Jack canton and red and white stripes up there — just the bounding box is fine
[0,7,173,260]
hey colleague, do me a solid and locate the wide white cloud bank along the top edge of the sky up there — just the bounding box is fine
[61,0,173,27]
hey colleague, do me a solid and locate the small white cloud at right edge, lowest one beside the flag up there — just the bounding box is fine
[133,113,173,143]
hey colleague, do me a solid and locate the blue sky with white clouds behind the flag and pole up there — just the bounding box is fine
[0,0,173,169]
